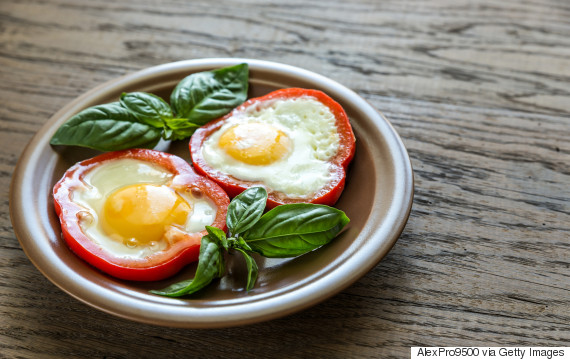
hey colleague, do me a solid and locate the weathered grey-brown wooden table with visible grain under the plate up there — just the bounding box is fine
[0,0,570,358]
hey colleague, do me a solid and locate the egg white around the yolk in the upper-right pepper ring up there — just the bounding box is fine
[202,96,340,199]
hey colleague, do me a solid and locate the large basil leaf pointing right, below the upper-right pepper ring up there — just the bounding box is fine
[243,203,349,258]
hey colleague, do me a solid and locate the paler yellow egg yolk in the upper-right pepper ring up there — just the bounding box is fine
[218,123,291,165]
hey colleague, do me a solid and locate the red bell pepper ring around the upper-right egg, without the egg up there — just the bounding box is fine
[189,88,356,208]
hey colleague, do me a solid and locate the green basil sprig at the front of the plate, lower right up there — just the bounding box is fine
[151,187,349,297]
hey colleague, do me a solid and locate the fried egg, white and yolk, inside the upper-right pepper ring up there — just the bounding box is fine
[201,96,340,199]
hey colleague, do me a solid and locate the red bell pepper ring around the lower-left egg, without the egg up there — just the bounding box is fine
[53,149,229,281]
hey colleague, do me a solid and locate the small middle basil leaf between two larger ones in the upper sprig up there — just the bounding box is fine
[121,92,174,127]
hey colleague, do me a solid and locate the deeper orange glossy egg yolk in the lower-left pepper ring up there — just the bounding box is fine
[101,184,191,246]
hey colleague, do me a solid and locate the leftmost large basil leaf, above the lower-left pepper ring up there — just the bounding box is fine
[50,102,162,151]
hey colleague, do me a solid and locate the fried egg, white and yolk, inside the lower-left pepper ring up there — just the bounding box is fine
[71,158,217,258]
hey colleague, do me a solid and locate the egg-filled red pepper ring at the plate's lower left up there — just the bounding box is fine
[53,149,229,281]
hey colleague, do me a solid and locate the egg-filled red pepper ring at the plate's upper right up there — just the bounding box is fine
[190,88,355,208]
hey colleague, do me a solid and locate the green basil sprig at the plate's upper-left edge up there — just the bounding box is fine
[50,63,249,151]
